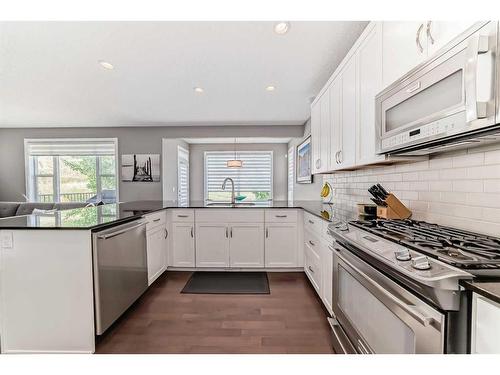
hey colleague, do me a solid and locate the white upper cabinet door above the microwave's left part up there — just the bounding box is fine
[382,21,427,87]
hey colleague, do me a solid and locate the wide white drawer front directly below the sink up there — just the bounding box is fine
[196,208,264,223]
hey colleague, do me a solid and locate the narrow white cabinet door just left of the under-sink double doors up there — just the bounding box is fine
[170,222,195,267]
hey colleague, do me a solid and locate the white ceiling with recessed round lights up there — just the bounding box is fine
[0,21,367,127]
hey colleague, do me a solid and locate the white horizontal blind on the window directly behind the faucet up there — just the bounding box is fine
[205,151,273,201]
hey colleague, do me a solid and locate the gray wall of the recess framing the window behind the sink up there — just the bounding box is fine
[189,143,288,201]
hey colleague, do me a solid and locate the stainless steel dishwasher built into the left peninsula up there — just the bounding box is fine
[92,219,148,335]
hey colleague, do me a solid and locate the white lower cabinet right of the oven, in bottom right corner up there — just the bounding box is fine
[471,293,500,354]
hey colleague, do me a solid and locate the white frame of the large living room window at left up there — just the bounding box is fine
[24,138,120,203]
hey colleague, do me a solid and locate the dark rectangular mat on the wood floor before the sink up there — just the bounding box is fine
[181,271,270,294]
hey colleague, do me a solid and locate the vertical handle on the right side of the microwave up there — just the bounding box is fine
[465,34,489,123]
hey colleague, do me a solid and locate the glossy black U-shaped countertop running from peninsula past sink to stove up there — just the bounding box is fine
[0,200,351,230]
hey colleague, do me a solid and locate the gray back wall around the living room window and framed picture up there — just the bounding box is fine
[0,125,303,201]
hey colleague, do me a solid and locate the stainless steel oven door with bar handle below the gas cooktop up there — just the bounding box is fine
[332,242,445,354]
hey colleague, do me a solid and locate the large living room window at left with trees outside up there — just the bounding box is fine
[24,138,118,203]
